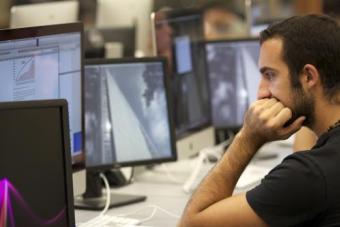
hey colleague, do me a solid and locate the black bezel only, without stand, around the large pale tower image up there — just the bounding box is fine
[84,57,177,171]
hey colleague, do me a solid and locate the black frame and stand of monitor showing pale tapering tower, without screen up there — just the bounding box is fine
[75,57,177,210]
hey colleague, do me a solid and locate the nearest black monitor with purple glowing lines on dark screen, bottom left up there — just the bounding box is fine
[0,100,75,227]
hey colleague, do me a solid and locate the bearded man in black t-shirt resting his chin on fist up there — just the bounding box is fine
[179,15,340,227]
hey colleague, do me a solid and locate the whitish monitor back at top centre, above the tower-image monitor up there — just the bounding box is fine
[96,0,154,56]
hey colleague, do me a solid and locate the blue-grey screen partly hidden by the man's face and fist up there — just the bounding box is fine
[206,39,261,129]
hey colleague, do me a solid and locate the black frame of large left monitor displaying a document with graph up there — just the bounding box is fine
[0,22,85,172]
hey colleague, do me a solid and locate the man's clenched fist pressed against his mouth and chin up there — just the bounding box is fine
[241,98,305,146]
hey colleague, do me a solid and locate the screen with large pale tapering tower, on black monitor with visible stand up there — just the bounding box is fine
[85,58,176,168]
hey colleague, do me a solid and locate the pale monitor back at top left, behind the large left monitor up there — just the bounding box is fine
[10,1,79,28]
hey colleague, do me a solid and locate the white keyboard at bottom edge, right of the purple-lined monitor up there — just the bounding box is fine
[77,215,140,227]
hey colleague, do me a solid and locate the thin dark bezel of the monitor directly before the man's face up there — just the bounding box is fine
[203,36,260,131]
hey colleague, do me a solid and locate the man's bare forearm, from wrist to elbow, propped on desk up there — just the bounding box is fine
[183,130,262,223]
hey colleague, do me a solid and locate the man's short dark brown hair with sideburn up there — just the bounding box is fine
[260,15,340,101]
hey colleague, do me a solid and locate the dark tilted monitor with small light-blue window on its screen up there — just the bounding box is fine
[152,10,210,138]
